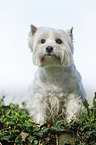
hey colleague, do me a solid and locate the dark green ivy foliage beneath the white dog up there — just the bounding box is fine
[0,93,96,145]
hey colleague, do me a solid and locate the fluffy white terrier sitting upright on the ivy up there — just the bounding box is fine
[27,25,85,124]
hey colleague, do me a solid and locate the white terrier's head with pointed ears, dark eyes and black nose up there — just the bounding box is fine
[29,25,73,67]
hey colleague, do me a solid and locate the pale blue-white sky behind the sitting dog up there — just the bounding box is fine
[0,0,96,103]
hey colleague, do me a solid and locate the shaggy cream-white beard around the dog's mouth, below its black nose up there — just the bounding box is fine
[33,46,73,67]
